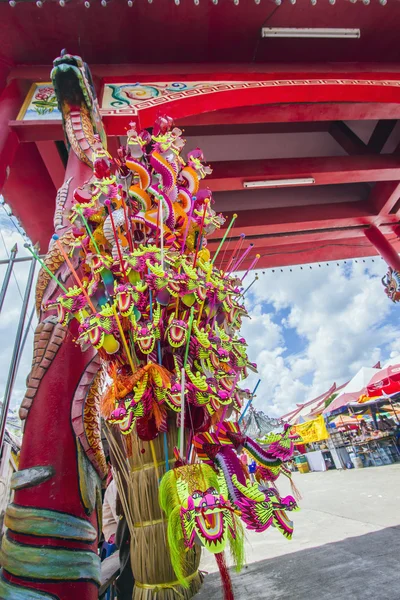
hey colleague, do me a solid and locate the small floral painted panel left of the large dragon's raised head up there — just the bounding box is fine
[17,83,61,121]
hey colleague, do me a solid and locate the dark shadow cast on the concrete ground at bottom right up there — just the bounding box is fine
[196,526,400,600]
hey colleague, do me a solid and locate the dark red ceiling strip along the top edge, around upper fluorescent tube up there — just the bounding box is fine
[0,0,400,65]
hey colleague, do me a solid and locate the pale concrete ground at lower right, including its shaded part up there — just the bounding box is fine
[196,464,400,600]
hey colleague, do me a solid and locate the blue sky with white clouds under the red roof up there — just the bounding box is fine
[0,208,400,416]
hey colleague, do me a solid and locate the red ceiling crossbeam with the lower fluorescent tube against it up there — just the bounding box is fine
[203,155,400,192]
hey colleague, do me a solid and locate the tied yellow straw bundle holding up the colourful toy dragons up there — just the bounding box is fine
[107,420,203,600]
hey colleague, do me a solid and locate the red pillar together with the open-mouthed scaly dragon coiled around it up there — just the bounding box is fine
[0,52,106,600]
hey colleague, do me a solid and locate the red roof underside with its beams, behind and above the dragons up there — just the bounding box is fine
[0,0,400,267]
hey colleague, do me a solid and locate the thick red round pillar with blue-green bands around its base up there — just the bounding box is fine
[0,153,101,600]
